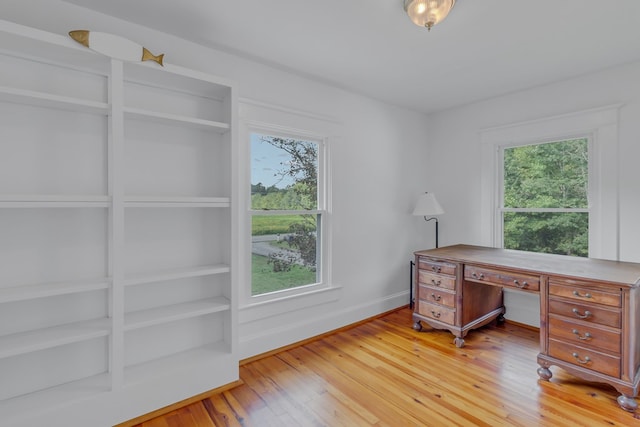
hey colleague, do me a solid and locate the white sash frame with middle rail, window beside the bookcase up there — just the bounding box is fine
[242,123,330,306]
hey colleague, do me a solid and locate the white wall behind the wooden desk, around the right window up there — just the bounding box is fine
[427,63,640,324]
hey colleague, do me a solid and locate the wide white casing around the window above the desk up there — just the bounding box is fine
[480,105,621,260]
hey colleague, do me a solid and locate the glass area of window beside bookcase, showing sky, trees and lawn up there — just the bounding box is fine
[250,133,325,296]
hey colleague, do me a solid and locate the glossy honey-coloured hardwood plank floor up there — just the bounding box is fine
[131,308,640,427]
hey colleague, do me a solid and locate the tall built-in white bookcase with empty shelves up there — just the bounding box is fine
[0,21,238,426]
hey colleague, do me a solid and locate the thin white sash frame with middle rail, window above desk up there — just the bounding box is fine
[495,134,599,255]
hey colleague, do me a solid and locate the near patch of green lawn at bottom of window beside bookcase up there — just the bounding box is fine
[251,255,316,295]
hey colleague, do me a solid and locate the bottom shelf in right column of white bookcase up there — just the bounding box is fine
[124,342,229,386]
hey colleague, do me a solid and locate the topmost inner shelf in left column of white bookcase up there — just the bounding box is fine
[0,86,109,115]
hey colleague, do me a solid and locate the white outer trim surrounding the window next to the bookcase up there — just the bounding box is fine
[238,120,332,308]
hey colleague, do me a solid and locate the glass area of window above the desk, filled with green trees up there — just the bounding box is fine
[499,138,589,257]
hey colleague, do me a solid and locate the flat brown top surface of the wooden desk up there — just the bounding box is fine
[415,245,640,287]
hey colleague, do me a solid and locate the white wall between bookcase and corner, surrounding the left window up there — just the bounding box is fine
[0,0,437,358]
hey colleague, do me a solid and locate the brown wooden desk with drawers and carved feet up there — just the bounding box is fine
[413,245,640,412]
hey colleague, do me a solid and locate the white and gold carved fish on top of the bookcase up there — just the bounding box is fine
[69,30,164,65]
